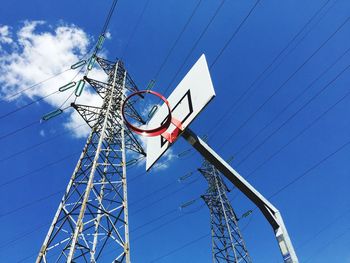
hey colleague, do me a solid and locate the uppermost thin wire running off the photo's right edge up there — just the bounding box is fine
[219,14,350,149]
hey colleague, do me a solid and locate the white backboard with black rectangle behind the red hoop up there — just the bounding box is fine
[146,54,215,171]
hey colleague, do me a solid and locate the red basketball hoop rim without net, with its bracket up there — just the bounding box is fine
[122,90,182,143]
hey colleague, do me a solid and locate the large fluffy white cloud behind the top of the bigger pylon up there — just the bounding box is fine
[0,21,106,137]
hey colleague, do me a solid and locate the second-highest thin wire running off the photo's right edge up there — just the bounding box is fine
[233,44,350,161]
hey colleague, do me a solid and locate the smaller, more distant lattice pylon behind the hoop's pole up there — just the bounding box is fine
[198,161,252,263]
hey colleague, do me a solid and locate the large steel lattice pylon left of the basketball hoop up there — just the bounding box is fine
[36,57,145,263]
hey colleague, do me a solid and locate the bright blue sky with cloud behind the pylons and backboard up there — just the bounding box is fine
[0,0,350,263]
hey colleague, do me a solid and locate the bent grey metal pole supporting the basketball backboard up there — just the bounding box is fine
[182,128,299,263]
